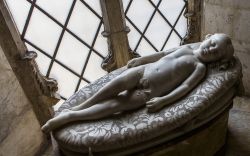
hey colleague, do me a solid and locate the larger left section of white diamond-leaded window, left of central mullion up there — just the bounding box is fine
[6,0,108,99]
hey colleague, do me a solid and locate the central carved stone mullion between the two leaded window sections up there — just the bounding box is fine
[100,0,138,72]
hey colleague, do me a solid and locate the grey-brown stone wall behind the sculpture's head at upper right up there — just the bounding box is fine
[202,0,250,96]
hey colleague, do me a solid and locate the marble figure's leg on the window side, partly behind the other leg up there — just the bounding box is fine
[72,66,144,111]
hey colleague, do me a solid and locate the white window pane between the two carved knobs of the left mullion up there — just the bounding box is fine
[26,44,51,75]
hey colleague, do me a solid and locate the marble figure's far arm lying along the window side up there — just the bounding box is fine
[127,46,181,68]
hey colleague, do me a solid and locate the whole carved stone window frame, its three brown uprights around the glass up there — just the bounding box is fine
[0,0,202,125]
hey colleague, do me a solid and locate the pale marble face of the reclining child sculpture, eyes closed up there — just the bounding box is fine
[195,34,231,62]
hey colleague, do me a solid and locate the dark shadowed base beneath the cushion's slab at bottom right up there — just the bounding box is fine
[136,110,229,156]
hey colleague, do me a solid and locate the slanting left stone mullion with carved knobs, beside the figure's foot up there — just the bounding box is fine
[0,1,58,125]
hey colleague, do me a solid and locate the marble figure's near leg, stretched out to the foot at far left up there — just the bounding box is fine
[42,90,146,133]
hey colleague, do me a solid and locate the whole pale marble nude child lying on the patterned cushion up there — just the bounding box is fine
[42,34,234,132]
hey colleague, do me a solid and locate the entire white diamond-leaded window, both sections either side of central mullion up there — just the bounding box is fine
[6,0,187,99]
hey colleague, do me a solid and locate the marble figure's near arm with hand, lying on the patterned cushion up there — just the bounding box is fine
[146,63,206,112]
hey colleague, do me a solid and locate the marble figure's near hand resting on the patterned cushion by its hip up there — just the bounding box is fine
[146,97,165,112]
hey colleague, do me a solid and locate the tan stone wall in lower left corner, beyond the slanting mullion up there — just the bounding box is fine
[0,44,44,156]
